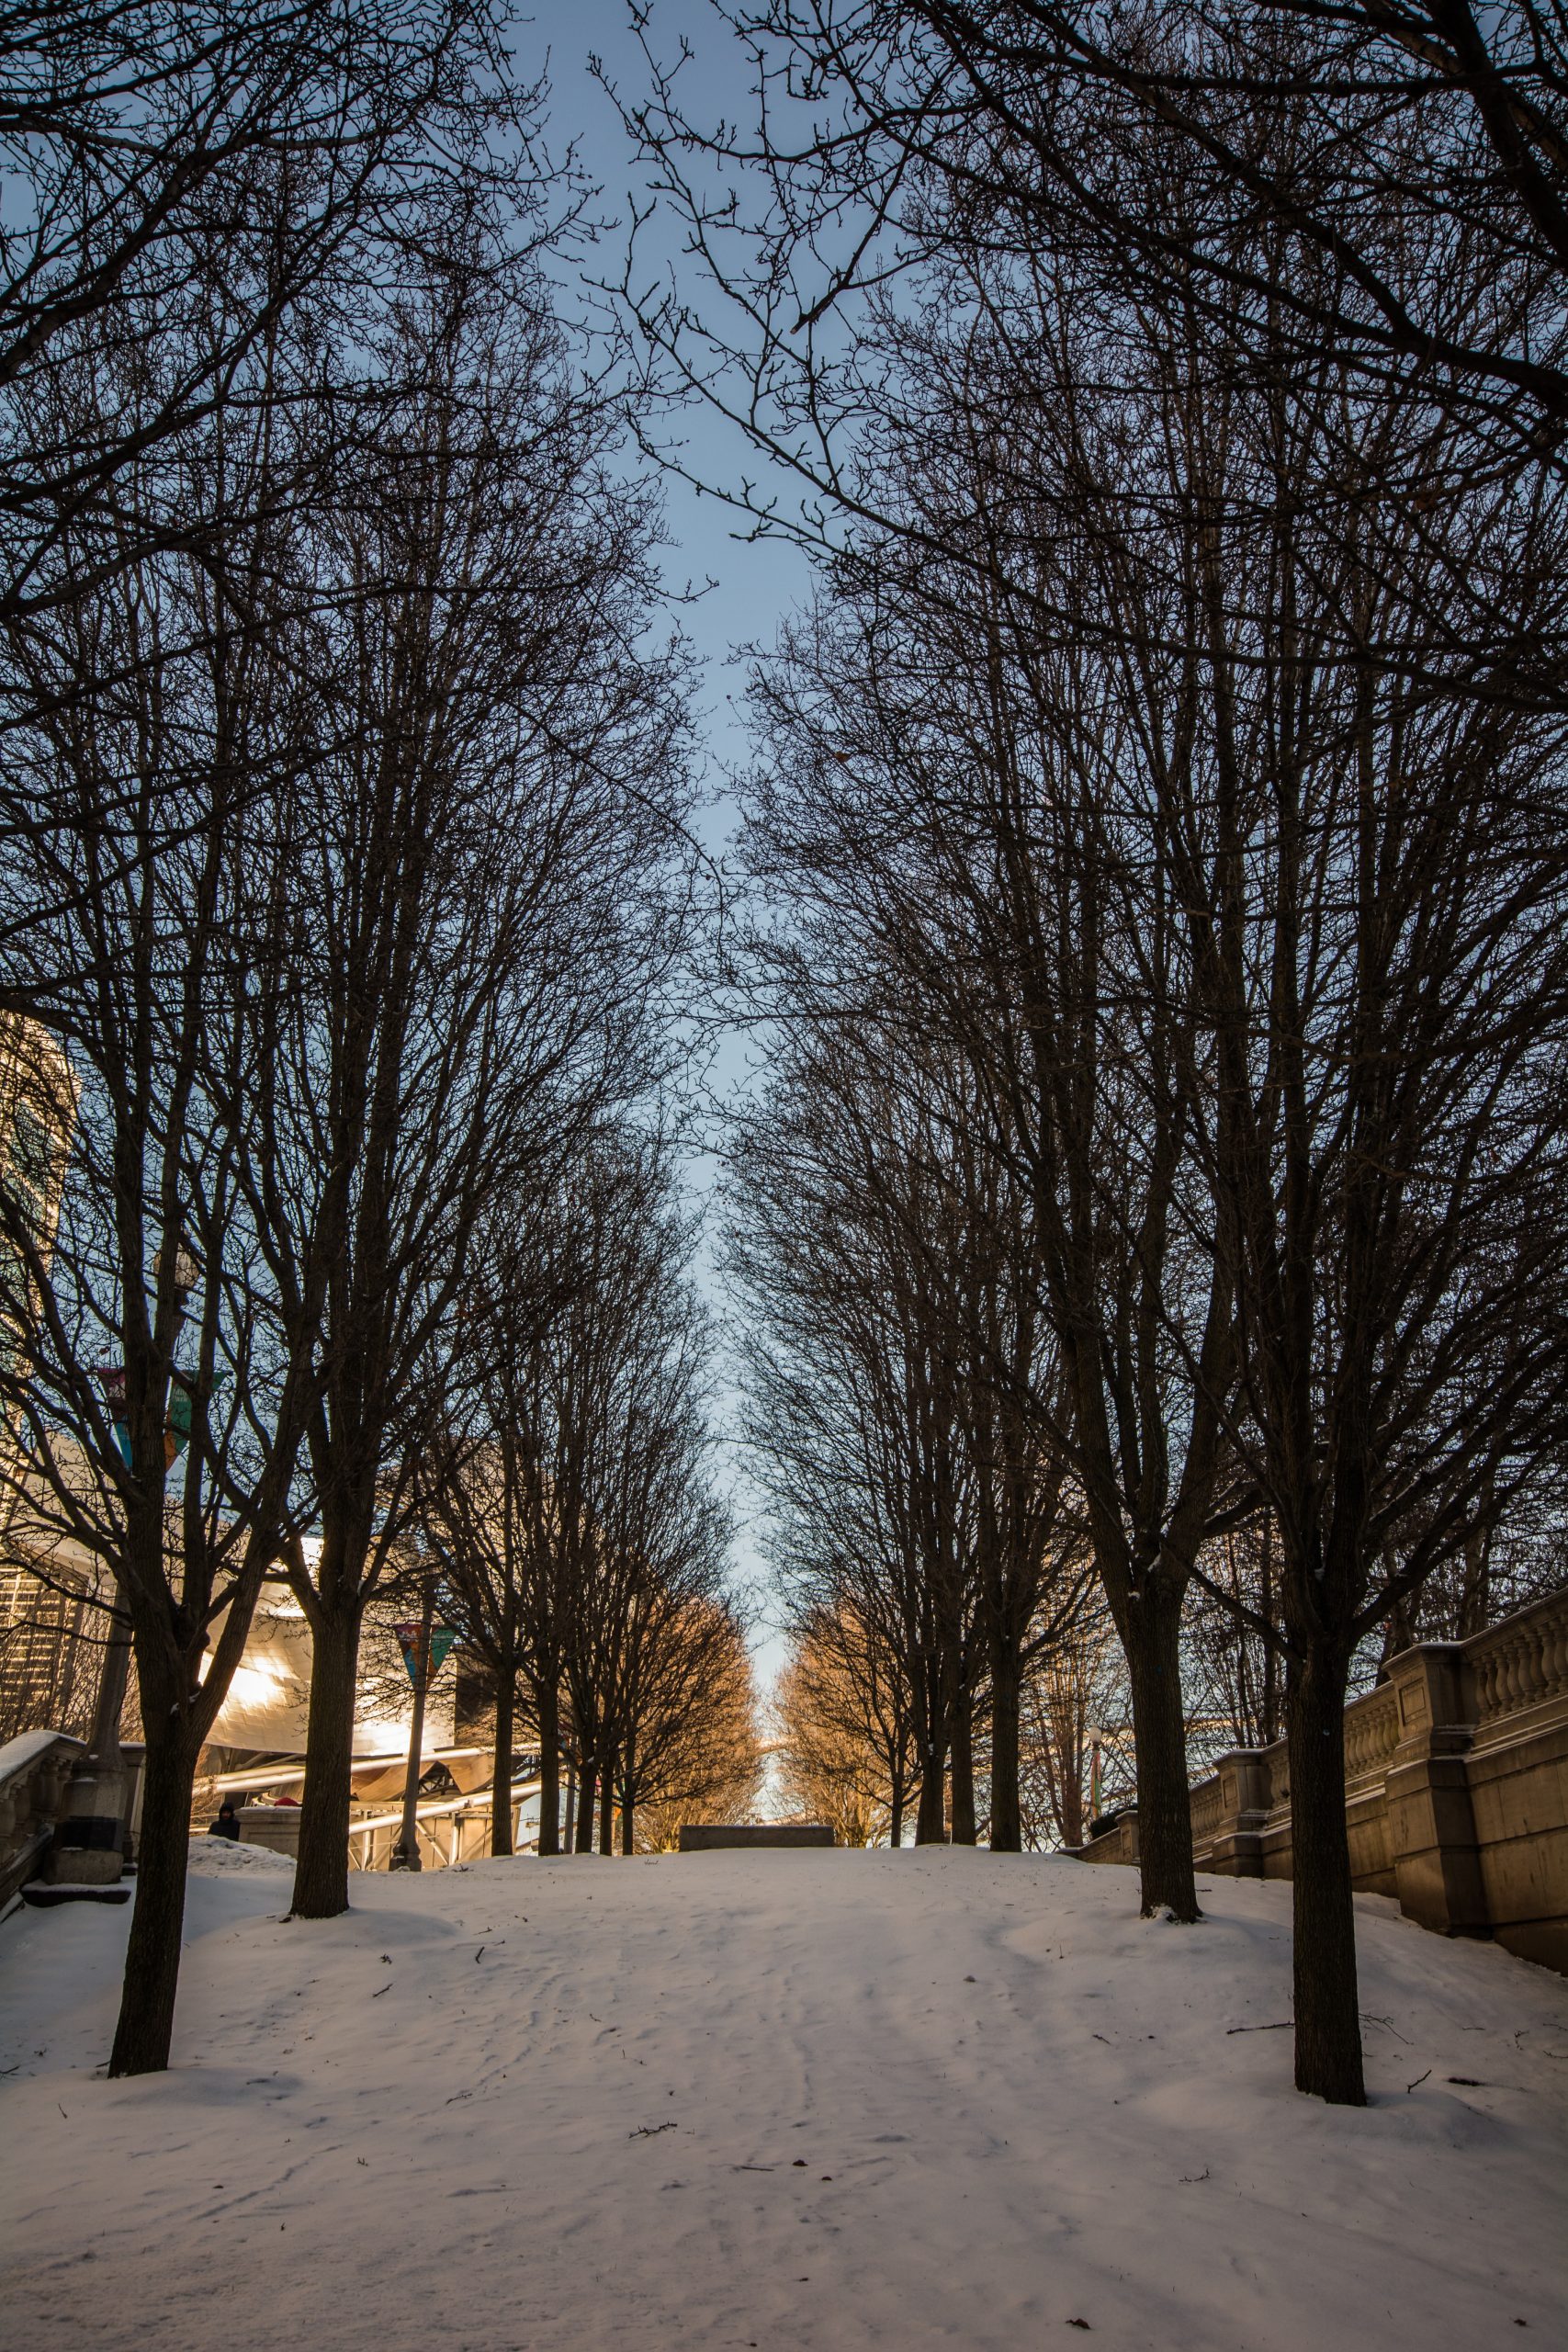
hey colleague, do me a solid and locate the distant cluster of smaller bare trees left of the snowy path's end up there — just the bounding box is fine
[416,1131,760,1853]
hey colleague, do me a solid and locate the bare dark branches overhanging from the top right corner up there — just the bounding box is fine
[667,0,1568,454]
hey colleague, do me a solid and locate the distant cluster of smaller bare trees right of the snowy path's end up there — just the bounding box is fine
[731,1030,1090,1851]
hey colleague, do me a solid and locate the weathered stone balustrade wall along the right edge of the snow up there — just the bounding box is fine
[1081,1588,1568,1973]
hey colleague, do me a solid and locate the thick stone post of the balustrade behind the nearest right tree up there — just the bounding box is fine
[1384,1642,1491,1936]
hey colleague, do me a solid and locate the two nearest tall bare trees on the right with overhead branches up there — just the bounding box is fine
[627,0,1568,2103]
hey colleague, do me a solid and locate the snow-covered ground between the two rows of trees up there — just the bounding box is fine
[0,1839,1568,2352]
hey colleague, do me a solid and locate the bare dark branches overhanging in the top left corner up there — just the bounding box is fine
[0,0,534,630]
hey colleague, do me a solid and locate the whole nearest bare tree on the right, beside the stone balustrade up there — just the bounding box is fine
[1170,376,1565,2100]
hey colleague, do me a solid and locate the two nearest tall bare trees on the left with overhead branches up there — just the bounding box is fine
[0,14,728,2072]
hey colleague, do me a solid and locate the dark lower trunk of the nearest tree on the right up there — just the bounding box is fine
[1286,1649,1366,2108]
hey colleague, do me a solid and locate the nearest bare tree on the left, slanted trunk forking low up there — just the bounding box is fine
[0,409,321,2072]
